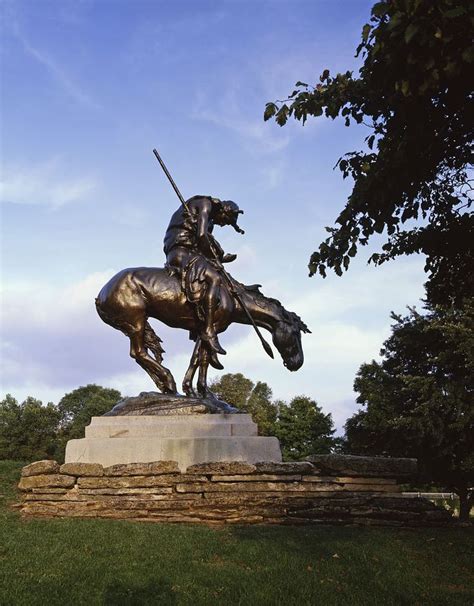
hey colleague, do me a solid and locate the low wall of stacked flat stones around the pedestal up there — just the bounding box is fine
[19,461,450,526]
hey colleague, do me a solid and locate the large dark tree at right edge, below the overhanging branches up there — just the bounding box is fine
[346,300,474,520]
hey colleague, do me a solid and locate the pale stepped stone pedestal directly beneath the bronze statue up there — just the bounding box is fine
[66,414,281,471]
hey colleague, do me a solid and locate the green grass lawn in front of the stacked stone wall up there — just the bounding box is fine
[0,461,474,606]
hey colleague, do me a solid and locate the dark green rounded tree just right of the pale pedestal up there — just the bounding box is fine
[274,396,334,461]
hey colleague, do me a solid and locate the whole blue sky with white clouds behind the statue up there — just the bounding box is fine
[0,0,425,430]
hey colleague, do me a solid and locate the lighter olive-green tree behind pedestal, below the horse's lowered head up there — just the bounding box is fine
[211,373,277,436]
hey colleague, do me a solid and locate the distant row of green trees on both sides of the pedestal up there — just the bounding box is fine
[0,380,339,462]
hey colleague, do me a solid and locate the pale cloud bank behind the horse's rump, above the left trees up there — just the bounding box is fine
[0,270,204,400]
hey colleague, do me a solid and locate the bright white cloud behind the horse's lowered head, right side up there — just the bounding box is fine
[207,258,423,430]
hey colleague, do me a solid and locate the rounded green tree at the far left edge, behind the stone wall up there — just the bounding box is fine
[0,395,60,461]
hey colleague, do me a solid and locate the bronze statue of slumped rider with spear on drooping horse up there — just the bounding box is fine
[96,150,310,408]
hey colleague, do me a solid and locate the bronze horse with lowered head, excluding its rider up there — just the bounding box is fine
[96,267,311,398]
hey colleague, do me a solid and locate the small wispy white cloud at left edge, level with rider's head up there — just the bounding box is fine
[0,159,97,209]
